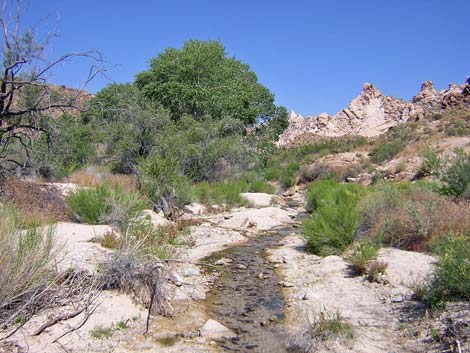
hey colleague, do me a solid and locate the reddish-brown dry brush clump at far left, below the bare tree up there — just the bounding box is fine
[4,178,69,224]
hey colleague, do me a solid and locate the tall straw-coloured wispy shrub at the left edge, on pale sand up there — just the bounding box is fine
[0,204,56,327]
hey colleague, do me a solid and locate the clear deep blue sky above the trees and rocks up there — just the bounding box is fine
[24,0,470,115]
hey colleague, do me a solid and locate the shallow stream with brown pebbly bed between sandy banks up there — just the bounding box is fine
[205,204,298,353]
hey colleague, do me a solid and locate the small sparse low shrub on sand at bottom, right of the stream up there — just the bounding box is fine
[287,311,354,353]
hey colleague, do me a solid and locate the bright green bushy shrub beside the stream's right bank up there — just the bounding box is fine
[302,180,362,256]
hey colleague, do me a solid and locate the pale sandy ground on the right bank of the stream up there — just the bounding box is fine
[270,235,435,353]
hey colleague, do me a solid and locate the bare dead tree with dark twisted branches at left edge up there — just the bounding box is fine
[0,0,103,176]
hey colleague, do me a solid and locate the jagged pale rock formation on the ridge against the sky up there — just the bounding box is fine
[278,77,470,146]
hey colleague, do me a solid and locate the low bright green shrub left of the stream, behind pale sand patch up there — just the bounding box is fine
[66,185,145,227]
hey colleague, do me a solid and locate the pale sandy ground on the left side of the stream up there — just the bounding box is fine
[0,192,296,353]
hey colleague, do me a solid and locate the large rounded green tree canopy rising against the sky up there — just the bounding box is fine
[135,40,275,125]
